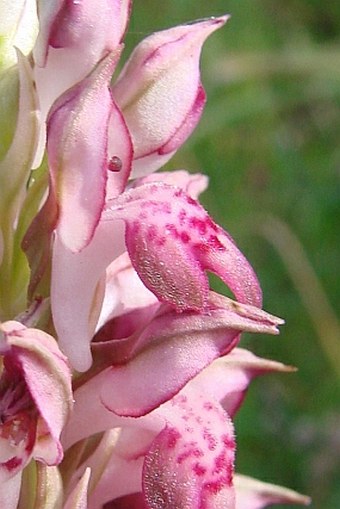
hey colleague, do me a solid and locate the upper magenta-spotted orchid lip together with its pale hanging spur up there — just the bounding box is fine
[51,169,261,371]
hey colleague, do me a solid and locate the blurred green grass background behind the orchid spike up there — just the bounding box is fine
[126,0,340,509]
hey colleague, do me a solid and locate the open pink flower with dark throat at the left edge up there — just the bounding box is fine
[0,321,73,507]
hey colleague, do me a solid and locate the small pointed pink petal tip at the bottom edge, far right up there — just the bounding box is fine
[234,474,311,509]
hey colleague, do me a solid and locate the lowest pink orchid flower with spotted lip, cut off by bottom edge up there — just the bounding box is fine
[63,349,309,509]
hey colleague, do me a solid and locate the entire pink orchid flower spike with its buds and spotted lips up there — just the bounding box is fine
[0,0,309,509]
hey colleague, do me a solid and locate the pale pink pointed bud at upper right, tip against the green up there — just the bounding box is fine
[113,16,228,177]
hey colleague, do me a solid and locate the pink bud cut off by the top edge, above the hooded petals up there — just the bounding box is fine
[34,0,131,167]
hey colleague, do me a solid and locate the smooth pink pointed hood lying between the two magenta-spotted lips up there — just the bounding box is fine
[100,298,280,417]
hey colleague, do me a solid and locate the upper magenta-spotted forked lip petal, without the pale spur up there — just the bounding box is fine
[103,183,262,311]
